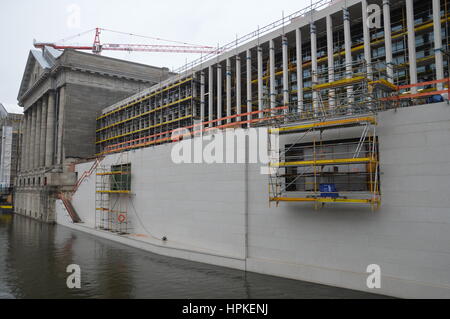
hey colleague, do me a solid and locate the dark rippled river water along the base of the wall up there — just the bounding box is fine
[0,213,386,299]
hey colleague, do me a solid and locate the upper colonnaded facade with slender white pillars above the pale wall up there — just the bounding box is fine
[96,0,450,154]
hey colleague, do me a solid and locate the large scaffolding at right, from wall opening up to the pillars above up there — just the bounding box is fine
[268,63,397,210]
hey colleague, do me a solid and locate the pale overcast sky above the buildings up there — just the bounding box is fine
[0,0,310,113]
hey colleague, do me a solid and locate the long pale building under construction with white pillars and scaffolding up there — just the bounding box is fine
[22,0,450,298]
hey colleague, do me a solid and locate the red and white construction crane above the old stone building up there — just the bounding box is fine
[34,28,219,55]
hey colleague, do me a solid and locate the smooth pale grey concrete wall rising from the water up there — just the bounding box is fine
[58,103,450,298]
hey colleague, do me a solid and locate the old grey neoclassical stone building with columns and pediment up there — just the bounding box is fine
[14,47,170,222]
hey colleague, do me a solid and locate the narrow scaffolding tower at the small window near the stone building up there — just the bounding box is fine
[95,158,131,235]
